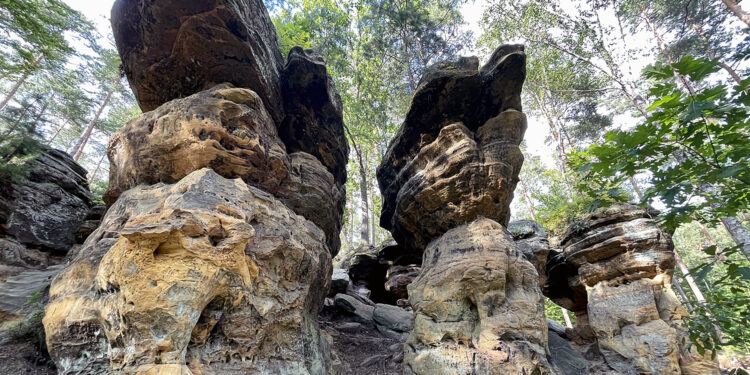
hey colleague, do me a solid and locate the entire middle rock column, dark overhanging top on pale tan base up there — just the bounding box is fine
[377,46,556,375]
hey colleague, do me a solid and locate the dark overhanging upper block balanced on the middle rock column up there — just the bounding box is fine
[377,46,526,253]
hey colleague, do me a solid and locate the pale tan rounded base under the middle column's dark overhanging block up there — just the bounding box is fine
[404,218,557,374]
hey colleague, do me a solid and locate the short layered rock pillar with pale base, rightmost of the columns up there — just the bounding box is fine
[560,204,718,374]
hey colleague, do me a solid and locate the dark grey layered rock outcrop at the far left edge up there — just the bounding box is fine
[0,148,95,321]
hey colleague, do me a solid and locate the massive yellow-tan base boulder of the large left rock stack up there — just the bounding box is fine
[43,169,331,374]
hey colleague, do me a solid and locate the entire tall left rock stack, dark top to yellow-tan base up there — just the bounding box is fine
[44,0,348,374]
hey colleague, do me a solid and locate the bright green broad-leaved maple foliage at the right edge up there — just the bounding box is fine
[576,57,750,230]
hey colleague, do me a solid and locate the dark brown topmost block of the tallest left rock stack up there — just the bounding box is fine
[112,0,284,123]
